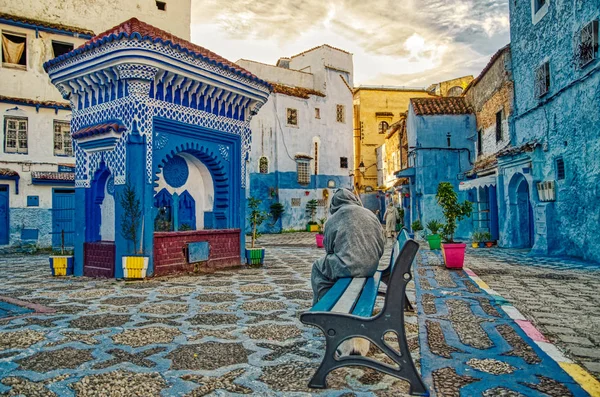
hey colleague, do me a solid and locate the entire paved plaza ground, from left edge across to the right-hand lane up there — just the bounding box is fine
[0,233,600,396]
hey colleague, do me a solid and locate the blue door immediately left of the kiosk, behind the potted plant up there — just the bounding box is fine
[52,189,75,248]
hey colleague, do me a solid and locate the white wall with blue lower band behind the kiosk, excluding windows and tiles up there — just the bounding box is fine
[238,47,354,231]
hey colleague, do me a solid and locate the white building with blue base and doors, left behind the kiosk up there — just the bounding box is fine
[0,0,190,249]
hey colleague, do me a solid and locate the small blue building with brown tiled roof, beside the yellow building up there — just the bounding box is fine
[396,97,475,238]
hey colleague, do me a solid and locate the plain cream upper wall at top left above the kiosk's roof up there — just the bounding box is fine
[0,0,191,40]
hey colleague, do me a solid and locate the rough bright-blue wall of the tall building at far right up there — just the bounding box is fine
[506,1,600,261]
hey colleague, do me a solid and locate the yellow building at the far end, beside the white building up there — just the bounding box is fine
[353,86,431,195]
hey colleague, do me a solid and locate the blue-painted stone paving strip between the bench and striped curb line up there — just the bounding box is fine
[416,249,588,397]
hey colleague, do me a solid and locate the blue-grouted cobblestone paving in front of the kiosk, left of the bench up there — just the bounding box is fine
[0,233,419,396]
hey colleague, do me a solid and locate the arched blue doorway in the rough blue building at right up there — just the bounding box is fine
[509,174,534,248]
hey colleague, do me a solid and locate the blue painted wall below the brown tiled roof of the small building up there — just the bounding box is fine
[407,105,476,239]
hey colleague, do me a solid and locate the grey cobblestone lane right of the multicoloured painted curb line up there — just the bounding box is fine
[465,248,600,379]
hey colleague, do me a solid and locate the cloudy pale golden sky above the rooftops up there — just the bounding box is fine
[192,0,510,87]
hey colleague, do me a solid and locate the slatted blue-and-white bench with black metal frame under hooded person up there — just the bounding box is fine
[300,230,429,396]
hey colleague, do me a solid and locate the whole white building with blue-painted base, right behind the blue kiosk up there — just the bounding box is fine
[237,45,354,232]
